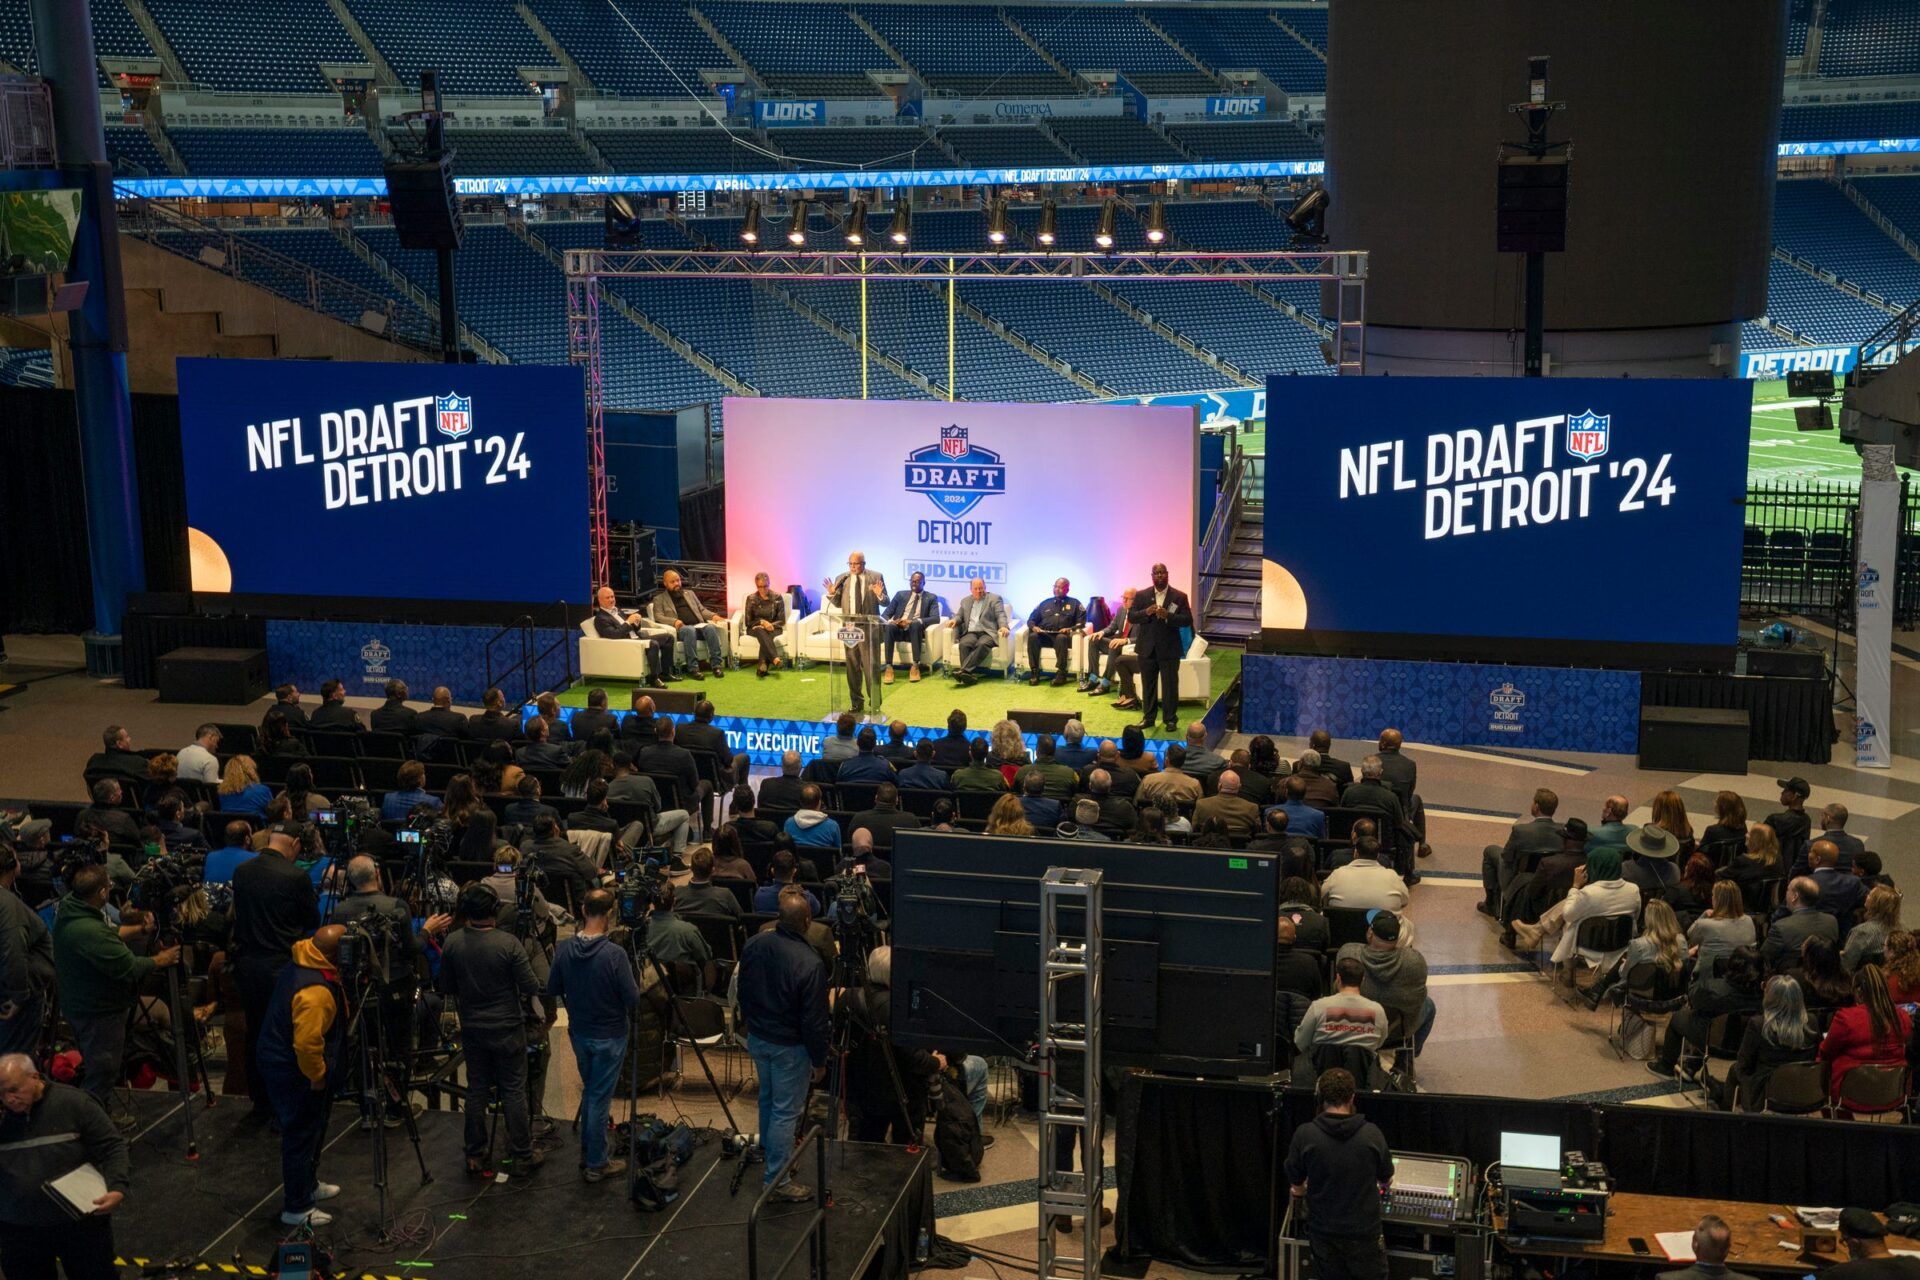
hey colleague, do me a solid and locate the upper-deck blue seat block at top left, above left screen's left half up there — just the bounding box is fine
[146,0,367,94]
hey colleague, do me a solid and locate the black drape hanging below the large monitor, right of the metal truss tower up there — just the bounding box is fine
[1114,1075,1279,1272]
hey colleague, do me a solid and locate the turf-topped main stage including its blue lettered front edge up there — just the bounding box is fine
[549,649,1240,766]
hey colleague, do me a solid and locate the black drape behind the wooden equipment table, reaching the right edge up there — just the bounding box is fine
[1597,1107,1920,1209]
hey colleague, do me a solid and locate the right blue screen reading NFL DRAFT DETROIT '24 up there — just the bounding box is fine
[1261,378,1751,664]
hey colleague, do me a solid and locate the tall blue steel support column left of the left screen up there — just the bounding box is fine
[29,0,146,676]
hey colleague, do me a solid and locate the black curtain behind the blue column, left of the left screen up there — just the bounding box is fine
[0,386,186,633]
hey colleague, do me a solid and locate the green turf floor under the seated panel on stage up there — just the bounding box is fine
[559,649,1240,739]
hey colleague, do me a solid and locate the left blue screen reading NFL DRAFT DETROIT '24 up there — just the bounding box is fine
[179,359,588,604]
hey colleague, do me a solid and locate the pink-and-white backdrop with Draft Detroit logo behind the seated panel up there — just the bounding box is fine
[726,399,1198,622]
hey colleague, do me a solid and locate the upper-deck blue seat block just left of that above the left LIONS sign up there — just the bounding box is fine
[528,0,737,98]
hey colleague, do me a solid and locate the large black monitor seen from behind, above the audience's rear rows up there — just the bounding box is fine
[891,831,1279,1075]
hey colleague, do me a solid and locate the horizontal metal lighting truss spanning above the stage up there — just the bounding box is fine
[566,249,1367,284]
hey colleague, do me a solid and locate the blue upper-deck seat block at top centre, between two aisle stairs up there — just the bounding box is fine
[858,4,1079,96]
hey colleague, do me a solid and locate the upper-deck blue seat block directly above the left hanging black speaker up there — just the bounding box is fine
[348,0,557,96]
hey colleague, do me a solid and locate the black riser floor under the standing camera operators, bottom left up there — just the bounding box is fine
[113,1092,933,1280]
